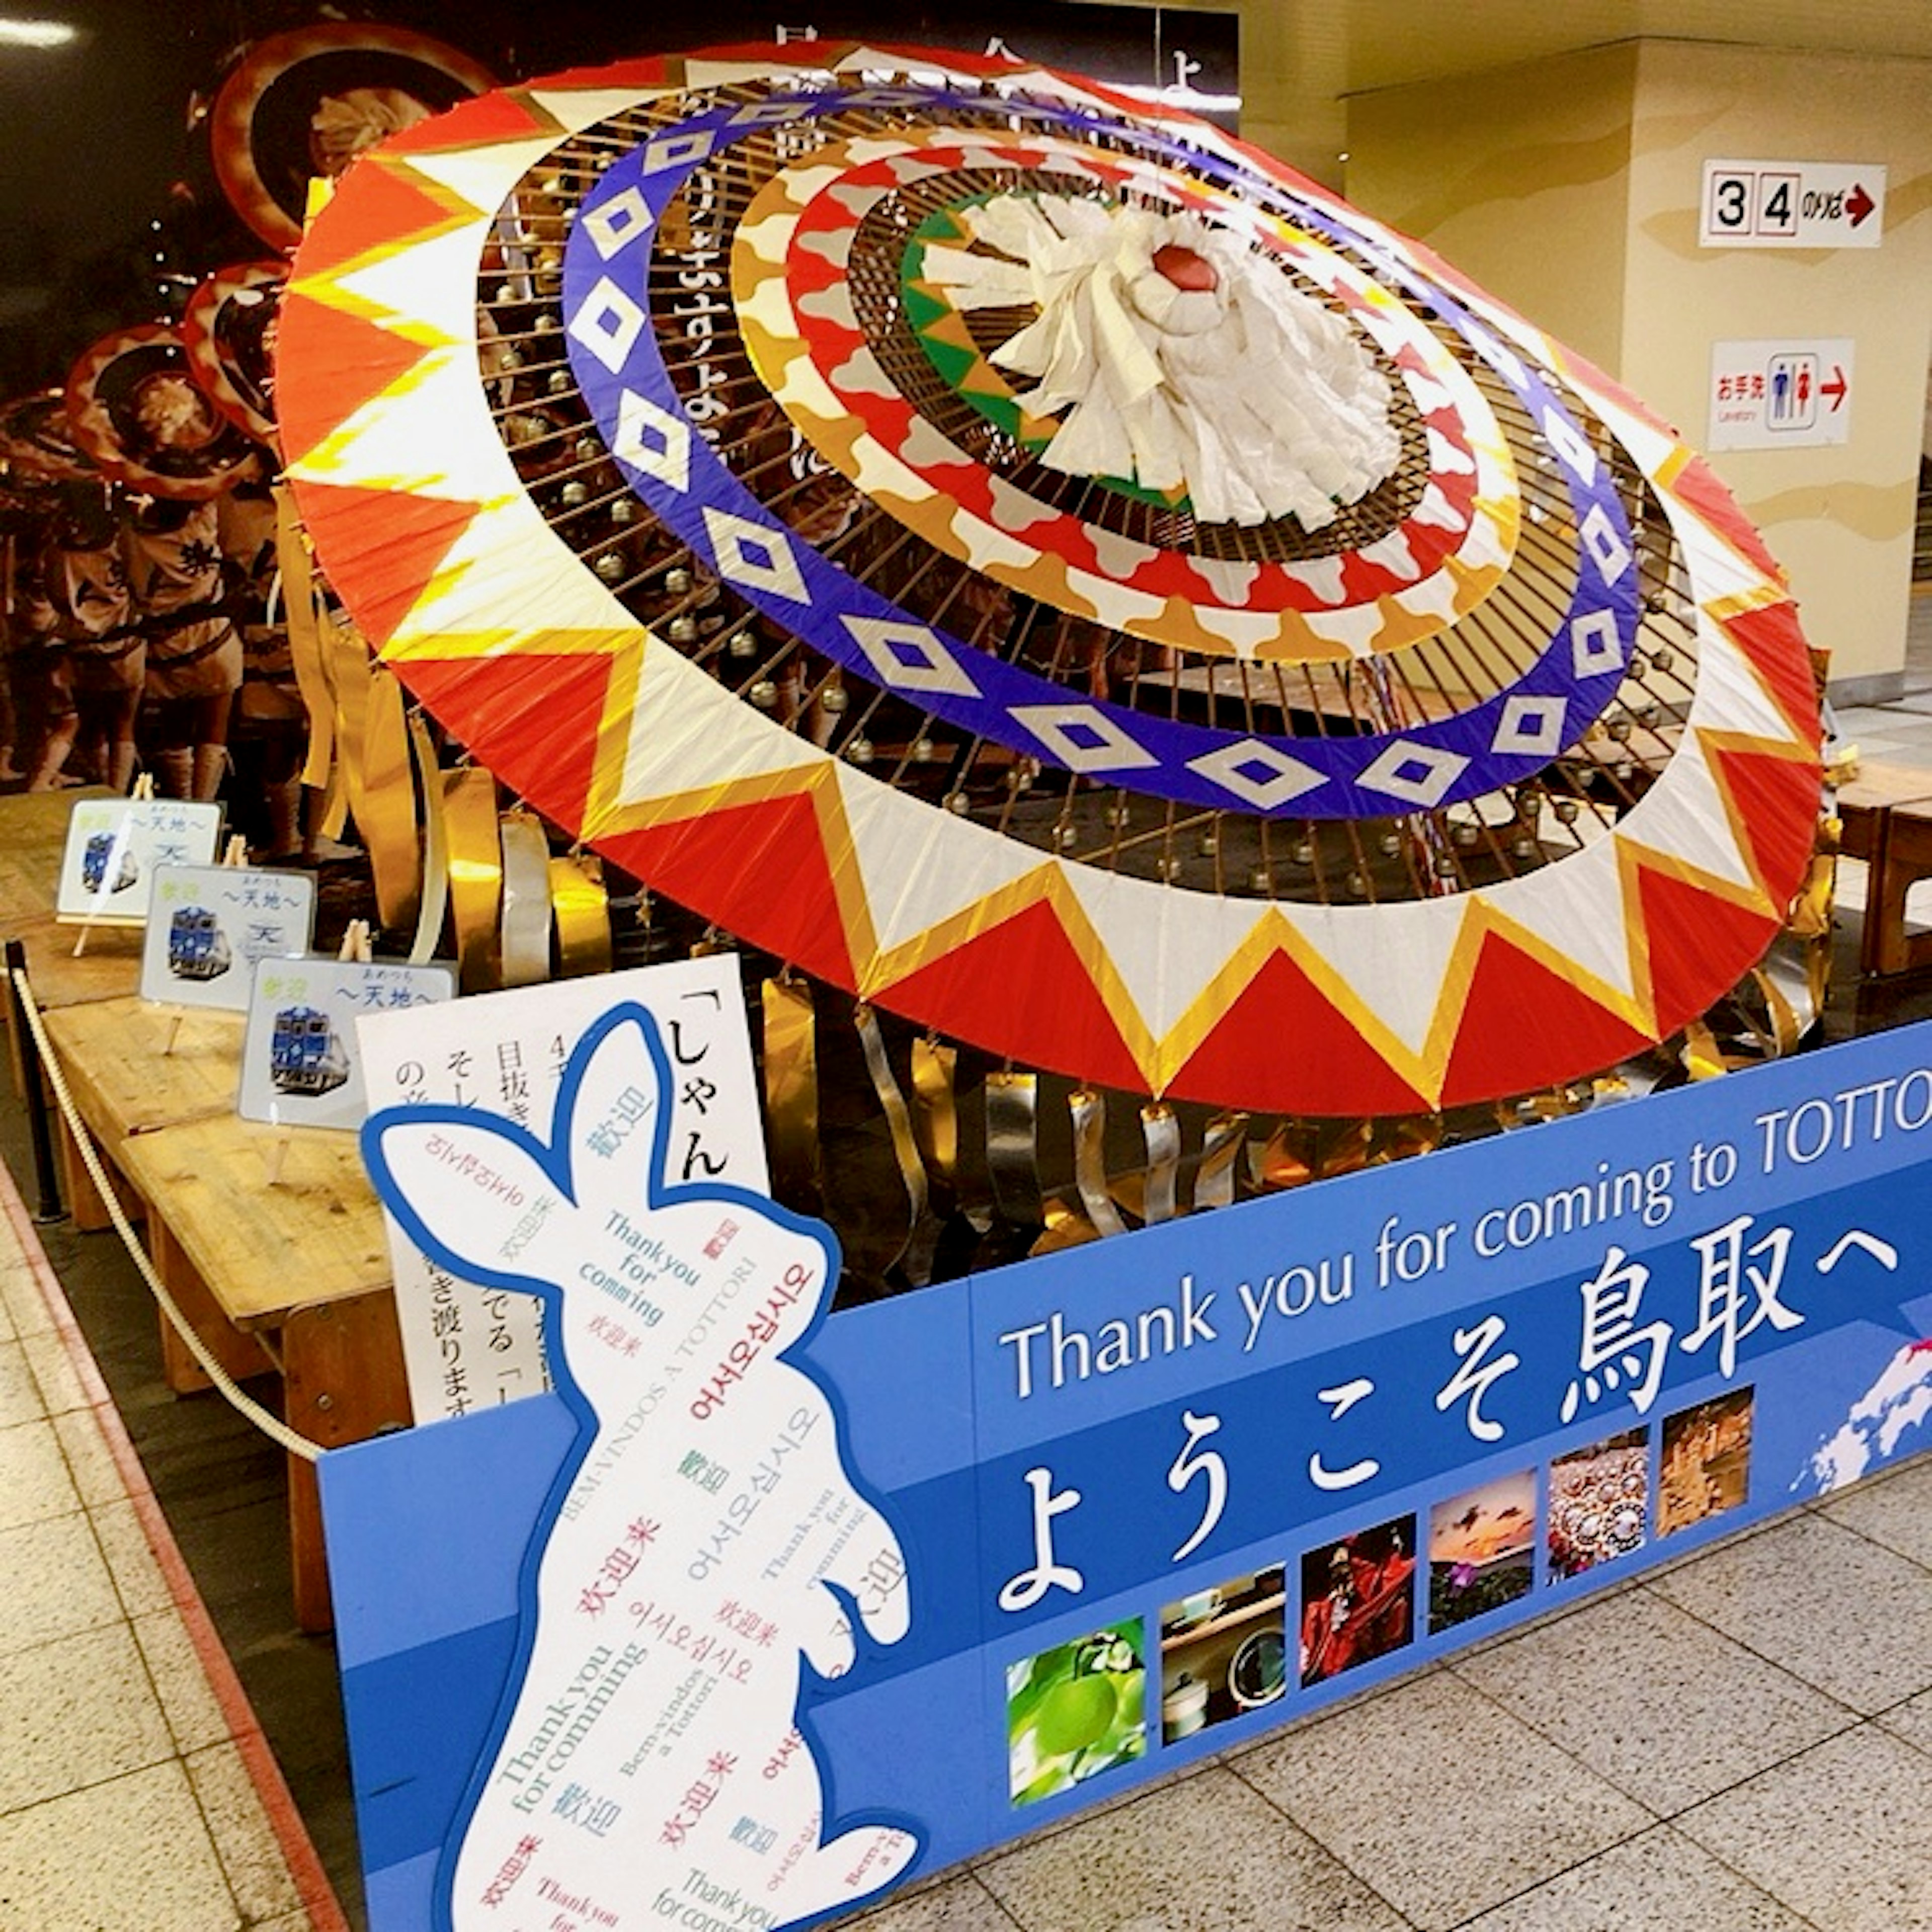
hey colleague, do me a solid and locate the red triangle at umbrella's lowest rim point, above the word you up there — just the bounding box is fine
[1175,952,1430,1115]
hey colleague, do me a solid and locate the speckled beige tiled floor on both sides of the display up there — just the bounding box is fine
[11,599,1932,1932]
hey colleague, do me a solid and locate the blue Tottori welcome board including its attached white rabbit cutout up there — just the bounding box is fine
[320,1008,1932,1932]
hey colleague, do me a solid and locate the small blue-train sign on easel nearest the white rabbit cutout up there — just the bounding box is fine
[235,958,456,1132]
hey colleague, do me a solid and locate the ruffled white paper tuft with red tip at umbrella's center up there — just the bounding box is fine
[924,193,1401,529]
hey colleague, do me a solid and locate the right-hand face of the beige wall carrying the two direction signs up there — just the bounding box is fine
[1621,41,1932,682]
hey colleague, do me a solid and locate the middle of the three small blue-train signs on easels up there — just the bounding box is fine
[141,865,315,1012]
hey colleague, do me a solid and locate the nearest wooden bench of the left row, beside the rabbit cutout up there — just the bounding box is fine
[122,1115,412,1631]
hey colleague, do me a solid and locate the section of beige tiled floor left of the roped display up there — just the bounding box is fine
[0,1175,344,1932]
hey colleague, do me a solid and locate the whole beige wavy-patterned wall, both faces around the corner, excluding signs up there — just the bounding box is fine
[1329,41,1932,690]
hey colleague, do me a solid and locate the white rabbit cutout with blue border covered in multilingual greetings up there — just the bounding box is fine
[363,1007,922,1932]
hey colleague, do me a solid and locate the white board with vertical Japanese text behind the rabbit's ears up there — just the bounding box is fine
[357,952,771,1422]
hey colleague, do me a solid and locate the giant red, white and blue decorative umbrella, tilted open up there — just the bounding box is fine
[278,44,1820,1115]
